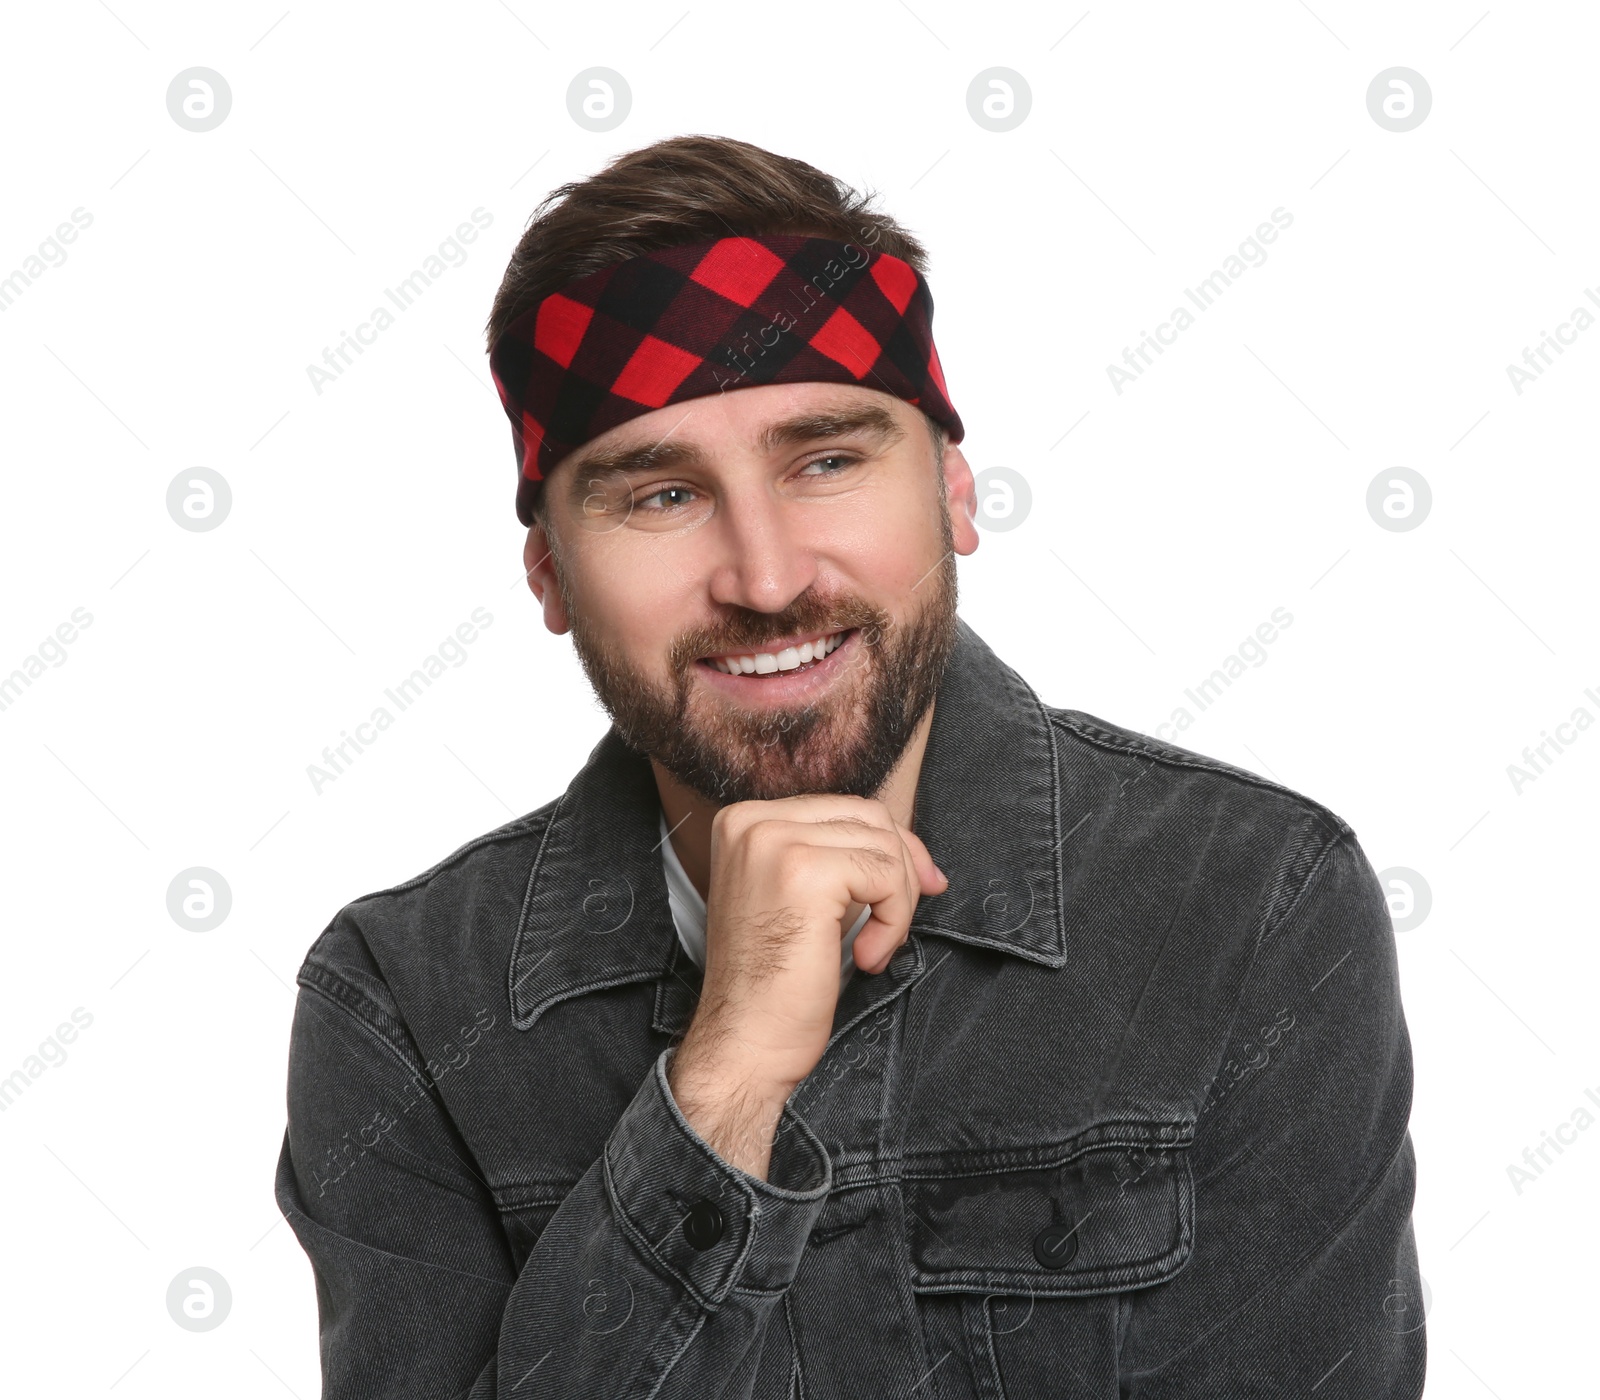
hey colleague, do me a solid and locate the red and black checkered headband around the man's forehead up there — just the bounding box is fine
[490,234,963,525]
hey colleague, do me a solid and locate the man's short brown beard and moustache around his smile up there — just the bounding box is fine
[554,508,957,806]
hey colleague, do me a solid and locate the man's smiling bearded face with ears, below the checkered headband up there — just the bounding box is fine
[526,382,978,803]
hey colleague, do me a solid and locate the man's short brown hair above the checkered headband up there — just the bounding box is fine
[485,136,946,521]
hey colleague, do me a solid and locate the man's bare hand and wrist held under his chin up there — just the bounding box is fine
[667,794,949,1176]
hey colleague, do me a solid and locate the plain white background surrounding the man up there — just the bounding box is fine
[0,0,1600,1400]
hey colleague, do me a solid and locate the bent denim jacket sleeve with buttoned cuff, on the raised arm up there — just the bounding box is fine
[277,970,832,1400]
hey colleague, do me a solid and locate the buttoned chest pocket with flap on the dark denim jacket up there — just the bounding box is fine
[901,1122,1195,1400]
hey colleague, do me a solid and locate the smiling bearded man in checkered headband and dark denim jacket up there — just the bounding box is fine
[277,138,1424,1400]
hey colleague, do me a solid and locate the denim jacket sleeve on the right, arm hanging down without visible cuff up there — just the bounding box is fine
[1117,829,1427,1400]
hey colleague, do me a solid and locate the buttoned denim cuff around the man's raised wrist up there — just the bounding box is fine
[605,1046,834,1306]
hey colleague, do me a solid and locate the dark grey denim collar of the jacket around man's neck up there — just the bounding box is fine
[509,621,1067,1030]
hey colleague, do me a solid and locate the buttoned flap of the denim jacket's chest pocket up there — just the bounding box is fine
[901,1123,1194,1296]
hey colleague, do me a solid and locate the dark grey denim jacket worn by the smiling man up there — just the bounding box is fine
[277,622,1426,1400]
